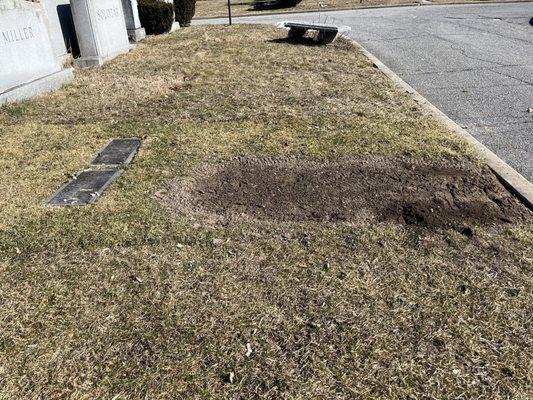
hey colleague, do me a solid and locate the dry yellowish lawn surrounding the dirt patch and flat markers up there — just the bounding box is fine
[0,26,533,400]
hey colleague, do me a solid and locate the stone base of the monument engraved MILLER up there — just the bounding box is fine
[0,68,74,106]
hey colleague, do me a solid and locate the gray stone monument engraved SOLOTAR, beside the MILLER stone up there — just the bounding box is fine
[70,0,133,68]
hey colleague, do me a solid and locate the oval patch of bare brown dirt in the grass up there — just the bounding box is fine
[161,157,531,233]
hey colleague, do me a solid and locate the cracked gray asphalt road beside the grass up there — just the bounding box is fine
[193,0,533,182]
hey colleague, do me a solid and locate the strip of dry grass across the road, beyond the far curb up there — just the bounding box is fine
[194,0,493,18]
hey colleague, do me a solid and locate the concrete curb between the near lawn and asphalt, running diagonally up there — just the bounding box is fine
[347,38,533,211]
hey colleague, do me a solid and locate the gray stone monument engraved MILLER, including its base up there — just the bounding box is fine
[0,0,74,105]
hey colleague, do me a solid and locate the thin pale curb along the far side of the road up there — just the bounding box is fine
[192,0,533,21]
